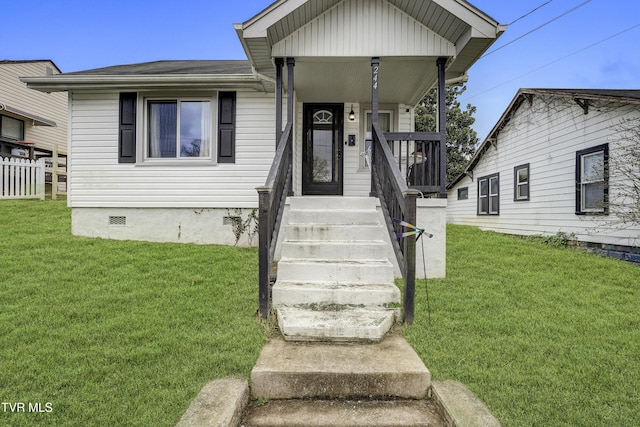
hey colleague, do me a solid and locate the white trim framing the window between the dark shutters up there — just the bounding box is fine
[136,91,218,166]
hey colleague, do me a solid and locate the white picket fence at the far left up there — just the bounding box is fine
[0,157,45,200]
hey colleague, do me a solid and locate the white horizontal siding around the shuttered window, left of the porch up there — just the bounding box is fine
[69,91,275,208]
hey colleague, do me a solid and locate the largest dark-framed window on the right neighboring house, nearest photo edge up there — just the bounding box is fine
[576,144,609,215]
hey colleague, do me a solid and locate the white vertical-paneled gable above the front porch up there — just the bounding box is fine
[272,0,456,57]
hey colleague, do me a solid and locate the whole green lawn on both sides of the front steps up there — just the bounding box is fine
[0,201,640,427]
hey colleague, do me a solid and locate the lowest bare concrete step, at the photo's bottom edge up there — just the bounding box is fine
[241,400,445,427]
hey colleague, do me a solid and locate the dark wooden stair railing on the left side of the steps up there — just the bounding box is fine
[256,122,293,319]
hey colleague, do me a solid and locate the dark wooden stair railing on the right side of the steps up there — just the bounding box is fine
[371,122,420,324]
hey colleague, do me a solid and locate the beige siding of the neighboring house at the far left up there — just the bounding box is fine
[0,61,67,154]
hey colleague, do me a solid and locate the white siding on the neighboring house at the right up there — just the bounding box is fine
[447,96,640,246]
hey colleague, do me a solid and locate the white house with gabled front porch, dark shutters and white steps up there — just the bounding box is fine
[23,0,504,332]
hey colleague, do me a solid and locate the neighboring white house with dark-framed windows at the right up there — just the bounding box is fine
[447,89,640,261]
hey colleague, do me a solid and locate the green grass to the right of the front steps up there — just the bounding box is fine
[405,226,640,427]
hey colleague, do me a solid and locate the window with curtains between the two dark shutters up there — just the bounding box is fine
[146,100,211,159]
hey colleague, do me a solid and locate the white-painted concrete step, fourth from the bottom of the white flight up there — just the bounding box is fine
[282,240,387,261]
